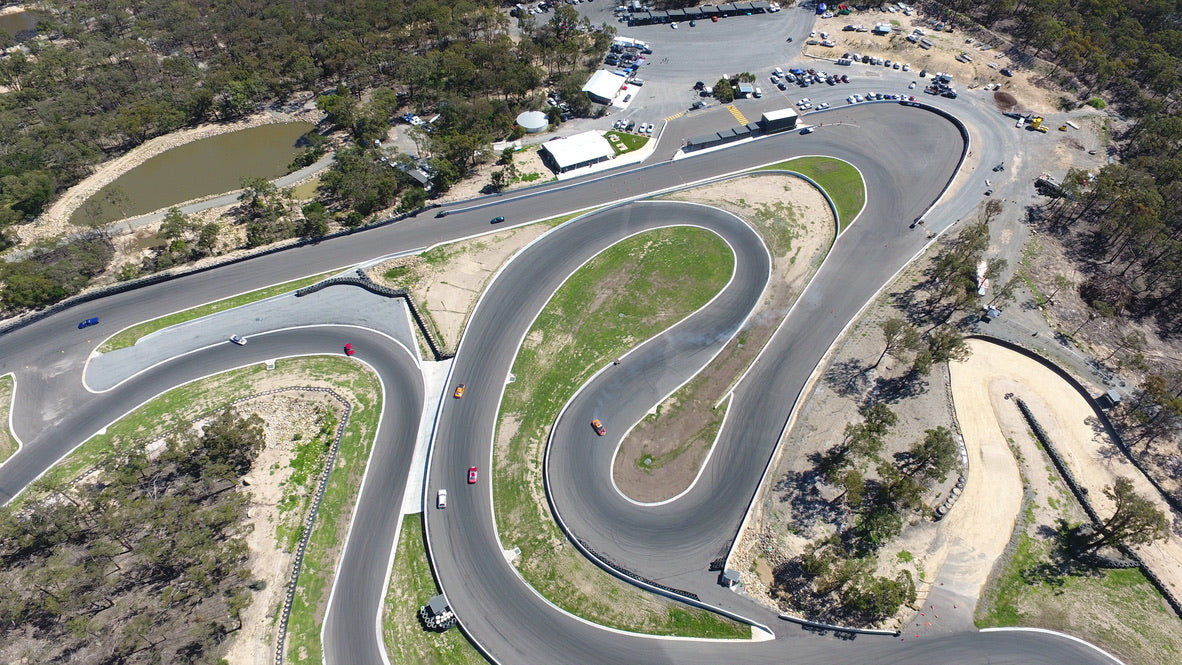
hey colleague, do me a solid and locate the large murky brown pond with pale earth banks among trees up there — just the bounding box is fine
[70,123,314,227]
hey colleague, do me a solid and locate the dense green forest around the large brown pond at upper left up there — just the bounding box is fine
[0,0,611,313]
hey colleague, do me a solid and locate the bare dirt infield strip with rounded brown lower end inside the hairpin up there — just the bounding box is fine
[612,175,836,501]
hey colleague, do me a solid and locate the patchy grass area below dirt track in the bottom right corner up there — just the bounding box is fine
[976,534,1182,665]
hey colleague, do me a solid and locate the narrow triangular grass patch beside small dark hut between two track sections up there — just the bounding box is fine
[382,514,487,665]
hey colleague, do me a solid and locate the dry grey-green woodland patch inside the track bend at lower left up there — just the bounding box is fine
[0,409,265,665]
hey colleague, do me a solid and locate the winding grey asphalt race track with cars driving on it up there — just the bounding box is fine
[0,100,1110,665]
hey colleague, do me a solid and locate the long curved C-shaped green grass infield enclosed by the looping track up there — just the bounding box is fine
[493,227,751,638]
